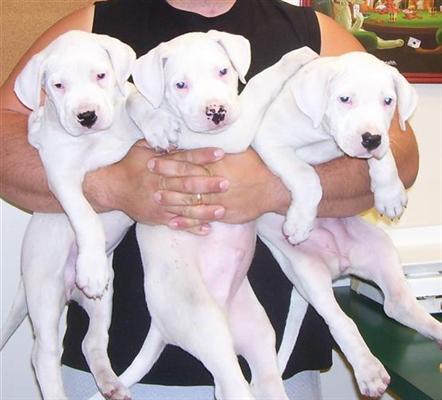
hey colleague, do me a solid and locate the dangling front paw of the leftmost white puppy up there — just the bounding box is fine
[75,252,109,299]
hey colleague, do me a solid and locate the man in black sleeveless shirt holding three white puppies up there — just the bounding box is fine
[0,0,418,399]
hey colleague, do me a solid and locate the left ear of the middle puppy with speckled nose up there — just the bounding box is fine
[132,43,167,108]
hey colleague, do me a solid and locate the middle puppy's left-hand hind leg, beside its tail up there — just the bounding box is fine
[156,282,254,400]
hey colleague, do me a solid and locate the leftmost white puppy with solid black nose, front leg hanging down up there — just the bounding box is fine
[1,31,139,400]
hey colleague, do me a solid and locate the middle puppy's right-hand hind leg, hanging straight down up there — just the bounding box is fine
[228,279,288,400]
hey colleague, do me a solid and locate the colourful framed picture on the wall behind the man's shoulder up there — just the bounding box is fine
[287,0,442,83]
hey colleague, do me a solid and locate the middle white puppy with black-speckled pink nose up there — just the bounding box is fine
[93,31,317,400]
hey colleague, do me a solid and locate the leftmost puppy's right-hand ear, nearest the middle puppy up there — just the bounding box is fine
[94,34,136,96]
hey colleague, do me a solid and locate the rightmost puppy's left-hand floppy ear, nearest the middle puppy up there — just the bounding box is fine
[289,59,336,128]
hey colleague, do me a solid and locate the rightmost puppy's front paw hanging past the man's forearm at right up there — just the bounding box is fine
[374,182,408,219]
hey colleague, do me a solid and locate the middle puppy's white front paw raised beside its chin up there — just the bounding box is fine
[140,109,181,151]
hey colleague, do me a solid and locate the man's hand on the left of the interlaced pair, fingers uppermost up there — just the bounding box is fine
[84,141,230,234]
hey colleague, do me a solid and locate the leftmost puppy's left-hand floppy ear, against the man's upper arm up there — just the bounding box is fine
[14,51,46,110]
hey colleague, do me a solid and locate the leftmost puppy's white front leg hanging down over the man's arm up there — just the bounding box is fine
[46,168,109,298]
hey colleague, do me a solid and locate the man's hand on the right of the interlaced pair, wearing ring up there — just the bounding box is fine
[157,149,290,226]
